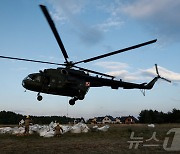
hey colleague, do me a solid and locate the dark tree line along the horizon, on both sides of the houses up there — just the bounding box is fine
[0,108,180,124]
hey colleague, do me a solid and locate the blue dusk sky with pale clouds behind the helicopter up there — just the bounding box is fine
[0,0,180,118]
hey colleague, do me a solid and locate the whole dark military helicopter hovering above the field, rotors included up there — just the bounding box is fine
[0,5,171,105]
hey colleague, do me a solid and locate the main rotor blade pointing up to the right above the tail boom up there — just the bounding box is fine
[74,39,157,64]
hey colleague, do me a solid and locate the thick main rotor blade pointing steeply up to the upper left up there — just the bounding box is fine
[39,5,68,63]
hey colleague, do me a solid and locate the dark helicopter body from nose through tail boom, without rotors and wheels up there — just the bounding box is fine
[22,68,160,103]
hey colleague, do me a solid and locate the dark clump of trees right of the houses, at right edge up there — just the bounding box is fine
[138,108,180,124]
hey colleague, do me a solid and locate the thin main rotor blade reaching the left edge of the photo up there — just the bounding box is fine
[0,56,65,66]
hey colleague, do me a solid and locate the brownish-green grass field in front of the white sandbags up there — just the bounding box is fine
[0,124,180,154]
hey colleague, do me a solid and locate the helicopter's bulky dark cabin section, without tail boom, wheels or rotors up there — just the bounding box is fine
[22,68,90,100]
